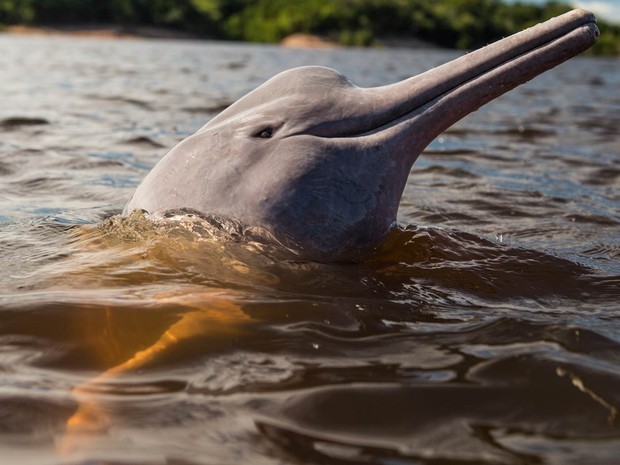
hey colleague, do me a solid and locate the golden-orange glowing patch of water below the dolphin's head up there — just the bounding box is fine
[55,212,275,454]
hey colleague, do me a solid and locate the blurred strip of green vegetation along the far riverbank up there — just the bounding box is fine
[0,0,620,55]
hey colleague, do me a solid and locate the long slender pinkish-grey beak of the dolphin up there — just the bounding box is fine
[320,10,599,143]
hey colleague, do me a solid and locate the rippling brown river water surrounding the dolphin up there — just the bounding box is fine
[0,36,620,465]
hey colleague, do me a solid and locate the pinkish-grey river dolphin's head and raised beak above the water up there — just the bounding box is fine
[123,10,599,261]
